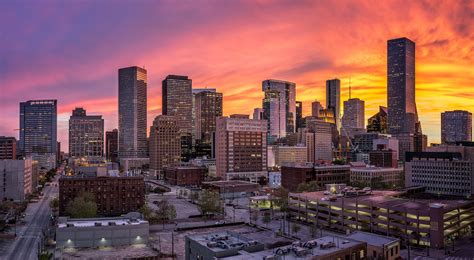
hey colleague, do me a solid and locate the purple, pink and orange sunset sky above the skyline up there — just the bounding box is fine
[0,0,474,151]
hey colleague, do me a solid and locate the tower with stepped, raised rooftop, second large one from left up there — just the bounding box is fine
[69,107,104,157]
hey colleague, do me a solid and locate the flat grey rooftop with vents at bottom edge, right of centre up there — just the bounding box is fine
[221,236,365,260]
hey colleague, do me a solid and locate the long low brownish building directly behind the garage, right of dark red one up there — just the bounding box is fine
[351,166,404,188]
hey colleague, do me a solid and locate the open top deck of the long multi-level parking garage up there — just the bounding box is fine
[290,190,474,212]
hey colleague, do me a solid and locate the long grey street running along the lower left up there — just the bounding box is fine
[1,180,58,260]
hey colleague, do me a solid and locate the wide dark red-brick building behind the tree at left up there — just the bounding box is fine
[59,175,145,216]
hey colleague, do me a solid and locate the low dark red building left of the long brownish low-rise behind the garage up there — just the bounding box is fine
[281,163,351,191]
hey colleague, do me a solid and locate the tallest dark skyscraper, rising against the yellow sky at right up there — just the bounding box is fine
[387,38,418,135]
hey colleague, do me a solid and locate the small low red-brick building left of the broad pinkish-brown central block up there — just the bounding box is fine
[164,166,206,186]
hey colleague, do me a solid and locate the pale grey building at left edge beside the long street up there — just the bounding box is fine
[0,158,32,201]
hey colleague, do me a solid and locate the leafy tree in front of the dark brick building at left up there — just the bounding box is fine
[66,192,97,218]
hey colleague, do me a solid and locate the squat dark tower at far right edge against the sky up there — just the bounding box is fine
[441,110,472,144]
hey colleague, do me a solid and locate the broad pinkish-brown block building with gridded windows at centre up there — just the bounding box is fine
[216,115,267,182]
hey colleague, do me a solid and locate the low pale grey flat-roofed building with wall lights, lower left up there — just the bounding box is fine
[56,213,150,249]
